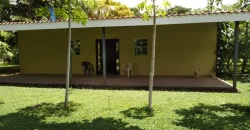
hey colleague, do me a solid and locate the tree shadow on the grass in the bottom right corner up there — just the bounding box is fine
[174,104,250,130]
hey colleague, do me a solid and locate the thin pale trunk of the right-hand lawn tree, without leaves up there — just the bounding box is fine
[148,0,156,109]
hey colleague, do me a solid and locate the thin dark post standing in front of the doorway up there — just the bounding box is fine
[102,27,106,82]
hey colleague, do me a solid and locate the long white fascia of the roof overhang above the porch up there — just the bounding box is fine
[0,11,250,31]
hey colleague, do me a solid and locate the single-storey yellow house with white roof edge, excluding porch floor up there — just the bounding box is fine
[0,11,250,88]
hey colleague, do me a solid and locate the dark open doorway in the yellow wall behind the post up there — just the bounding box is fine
[96,39,120,75]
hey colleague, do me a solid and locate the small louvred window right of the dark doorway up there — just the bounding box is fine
[135,39,148,55]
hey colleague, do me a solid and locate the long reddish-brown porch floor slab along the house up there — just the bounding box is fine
[0,75,233,91]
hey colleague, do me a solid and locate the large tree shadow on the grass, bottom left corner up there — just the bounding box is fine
[0,102,142,130]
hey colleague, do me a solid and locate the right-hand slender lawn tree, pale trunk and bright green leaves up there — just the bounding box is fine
[137,0,171,110]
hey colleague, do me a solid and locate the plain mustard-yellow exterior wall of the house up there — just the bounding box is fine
[19,23,216,76]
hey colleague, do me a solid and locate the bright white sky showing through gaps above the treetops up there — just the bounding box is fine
[114,0,237,9]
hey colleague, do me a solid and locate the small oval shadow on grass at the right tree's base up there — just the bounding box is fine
[121,107,154,119]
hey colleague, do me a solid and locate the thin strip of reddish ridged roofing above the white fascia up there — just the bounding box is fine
[0,10,250,25]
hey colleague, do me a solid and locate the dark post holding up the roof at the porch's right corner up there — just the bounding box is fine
[233,21,240,89]
